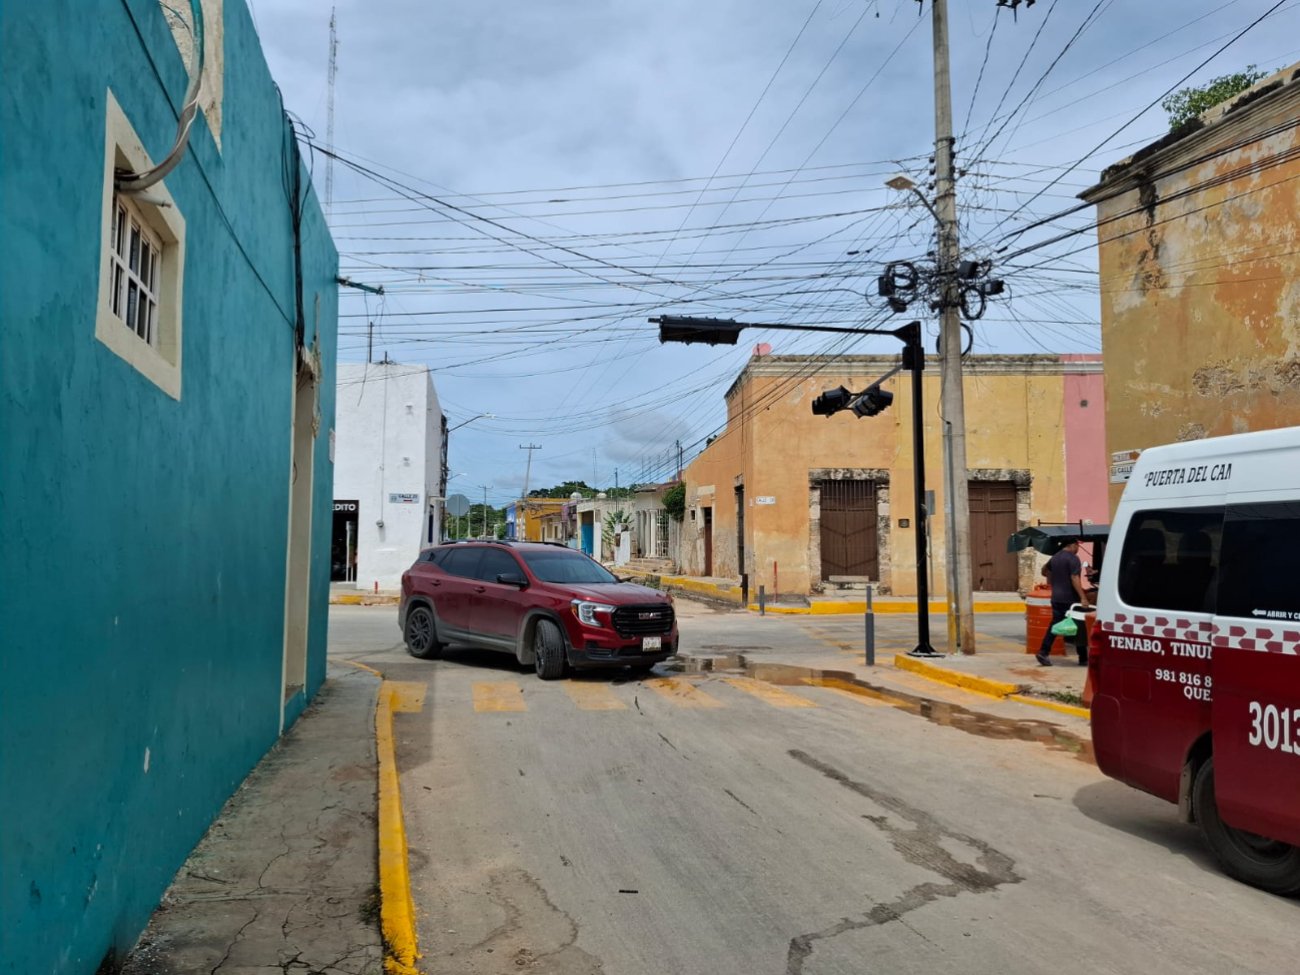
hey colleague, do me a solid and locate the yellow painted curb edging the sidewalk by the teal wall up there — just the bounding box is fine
[377,681,424,975]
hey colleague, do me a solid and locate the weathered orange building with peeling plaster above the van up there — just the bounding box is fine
[1083,64,1300,506]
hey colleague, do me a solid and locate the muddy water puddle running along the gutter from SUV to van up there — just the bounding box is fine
[657,653,1095,762]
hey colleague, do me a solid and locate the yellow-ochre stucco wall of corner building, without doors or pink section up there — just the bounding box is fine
[679,356,1105,595]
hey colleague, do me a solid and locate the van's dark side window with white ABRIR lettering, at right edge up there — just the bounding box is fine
[1218,501,1300,620]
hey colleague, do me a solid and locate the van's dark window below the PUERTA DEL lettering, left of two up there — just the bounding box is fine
[1119,507,1223,612]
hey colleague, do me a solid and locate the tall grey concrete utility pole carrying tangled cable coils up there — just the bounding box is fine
[930,0,975,654]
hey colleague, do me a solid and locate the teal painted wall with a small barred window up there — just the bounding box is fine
[0,0,337,975]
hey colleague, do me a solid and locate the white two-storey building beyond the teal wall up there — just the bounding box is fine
[330,363,447,589]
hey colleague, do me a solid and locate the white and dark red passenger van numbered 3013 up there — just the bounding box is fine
[1088,426,1300,894]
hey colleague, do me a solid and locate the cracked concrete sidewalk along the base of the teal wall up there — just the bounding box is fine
[121,664,384,975]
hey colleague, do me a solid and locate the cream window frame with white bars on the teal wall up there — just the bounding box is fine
[95,90,185,399]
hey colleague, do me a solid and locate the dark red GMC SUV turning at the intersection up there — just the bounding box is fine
[398,541,677,680]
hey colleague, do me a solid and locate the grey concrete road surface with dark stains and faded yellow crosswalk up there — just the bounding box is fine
[330,606,1300,975]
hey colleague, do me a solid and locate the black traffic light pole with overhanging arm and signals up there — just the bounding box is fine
[650,315,943,663]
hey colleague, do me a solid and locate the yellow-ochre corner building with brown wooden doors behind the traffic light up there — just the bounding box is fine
[677,355,1108,595]
